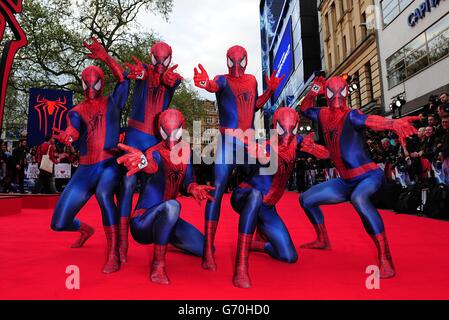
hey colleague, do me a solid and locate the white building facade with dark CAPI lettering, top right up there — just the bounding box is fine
[376,0,449,115]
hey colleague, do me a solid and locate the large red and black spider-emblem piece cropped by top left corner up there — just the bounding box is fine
[0,0,28,130]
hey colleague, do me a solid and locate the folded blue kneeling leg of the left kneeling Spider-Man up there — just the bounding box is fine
[170,218,204,257]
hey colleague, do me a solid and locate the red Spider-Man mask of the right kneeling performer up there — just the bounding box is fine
[273,107,300,147]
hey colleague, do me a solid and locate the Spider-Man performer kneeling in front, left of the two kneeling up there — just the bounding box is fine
[117,109,214,284]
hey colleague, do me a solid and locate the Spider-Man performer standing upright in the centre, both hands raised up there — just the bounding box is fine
[194,46,283,271]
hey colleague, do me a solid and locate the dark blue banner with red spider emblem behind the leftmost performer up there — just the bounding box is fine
[27,88,73,146]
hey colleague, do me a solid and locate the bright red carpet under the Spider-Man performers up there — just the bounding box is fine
[0,193,449,299]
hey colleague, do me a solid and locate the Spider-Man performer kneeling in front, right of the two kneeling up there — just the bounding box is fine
[231,107,329,288]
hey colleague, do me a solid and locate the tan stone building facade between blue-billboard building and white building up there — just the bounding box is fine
[318,0,383,114]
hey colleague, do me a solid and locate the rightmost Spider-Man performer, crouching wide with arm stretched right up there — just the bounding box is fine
[300,76,418,278]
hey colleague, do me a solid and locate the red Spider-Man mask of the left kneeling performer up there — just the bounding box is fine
[159,109,185,150]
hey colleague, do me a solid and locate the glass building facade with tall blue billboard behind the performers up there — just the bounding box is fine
[260,0,321,128]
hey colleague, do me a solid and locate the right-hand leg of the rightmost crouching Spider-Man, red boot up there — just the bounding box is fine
[351,173,395,278]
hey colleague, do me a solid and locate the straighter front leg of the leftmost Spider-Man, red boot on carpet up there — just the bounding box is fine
[95,164,120,273]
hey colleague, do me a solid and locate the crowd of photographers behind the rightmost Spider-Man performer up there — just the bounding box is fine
[289,93,449,192]
